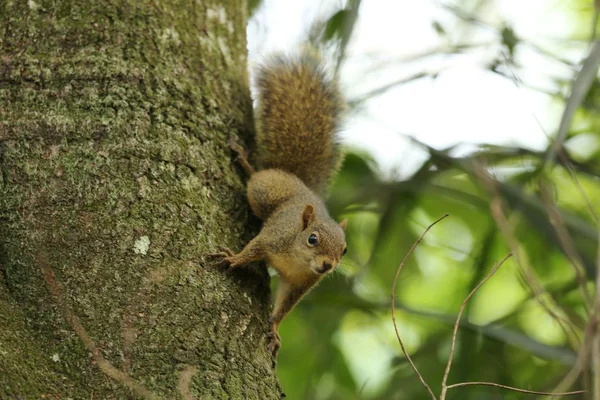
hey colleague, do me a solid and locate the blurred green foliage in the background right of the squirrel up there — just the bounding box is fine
[266,1,600,400]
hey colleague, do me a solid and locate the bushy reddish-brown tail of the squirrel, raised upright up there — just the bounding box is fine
[256,51,344,193]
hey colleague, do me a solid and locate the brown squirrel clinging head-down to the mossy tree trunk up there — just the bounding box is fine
[213,52,347,357]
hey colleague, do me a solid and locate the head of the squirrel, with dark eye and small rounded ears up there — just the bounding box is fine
[297,204,347,275]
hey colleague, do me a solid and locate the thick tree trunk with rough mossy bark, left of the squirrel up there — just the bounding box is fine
[0,0,281,399]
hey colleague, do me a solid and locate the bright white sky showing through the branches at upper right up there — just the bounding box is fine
[248,0,585,174]
